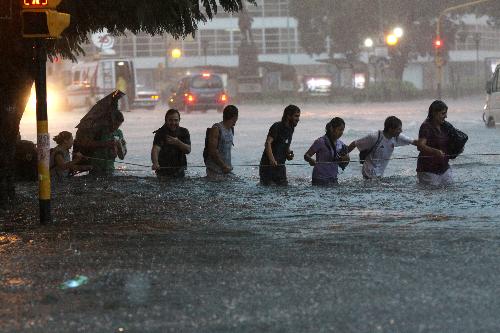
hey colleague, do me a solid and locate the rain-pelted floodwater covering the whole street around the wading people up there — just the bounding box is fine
[0,97,500,332]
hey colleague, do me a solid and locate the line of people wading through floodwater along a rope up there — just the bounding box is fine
[50,100,467,186]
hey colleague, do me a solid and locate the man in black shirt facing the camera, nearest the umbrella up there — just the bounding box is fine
[151,109,191,179]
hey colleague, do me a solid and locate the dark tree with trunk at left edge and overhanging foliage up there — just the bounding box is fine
[0,0,250,206]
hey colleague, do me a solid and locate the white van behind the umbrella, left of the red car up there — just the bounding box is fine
[66,58,136,109]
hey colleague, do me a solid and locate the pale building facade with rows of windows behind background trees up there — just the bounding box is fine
[76,0,500,89]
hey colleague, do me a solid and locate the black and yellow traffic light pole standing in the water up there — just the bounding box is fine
[35,39,51,224]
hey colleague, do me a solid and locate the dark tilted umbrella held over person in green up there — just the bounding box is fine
[76,90,125,129]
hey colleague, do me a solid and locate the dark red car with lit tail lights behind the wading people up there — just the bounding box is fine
[168,73,229,112]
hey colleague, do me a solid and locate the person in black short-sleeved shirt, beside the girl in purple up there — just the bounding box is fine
[259,105,300,185]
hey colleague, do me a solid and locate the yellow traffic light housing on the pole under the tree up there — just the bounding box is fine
[20,0,70,38]
